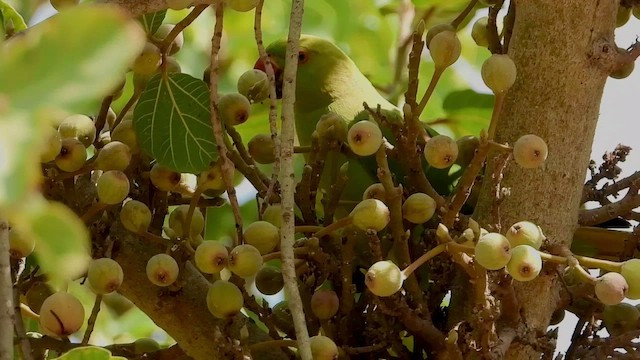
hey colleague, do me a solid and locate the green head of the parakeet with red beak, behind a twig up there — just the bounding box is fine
[255,35,359,102]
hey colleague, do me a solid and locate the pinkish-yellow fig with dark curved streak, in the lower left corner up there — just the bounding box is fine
[40,291,84,337]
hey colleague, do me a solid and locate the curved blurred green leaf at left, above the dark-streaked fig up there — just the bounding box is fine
[12,198,91,284]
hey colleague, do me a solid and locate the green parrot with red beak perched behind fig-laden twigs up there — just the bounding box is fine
[255,35,460,210]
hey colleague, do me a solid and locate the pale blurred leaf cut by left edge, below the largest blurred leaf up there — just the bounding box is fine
[0,112,42,208]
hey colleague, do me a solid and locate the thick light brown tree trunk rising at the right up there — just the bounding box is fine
[476,0,618,359]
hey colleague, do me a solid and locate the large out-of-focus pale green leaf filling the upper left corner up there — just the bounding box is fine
[0,5,146,111]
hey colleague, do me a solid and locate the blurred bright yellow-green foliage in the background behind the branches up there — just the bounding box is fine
[7,0,493,345]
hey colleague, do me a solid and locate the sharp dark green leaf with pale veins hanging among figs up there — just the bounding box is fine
[133,73,218,173]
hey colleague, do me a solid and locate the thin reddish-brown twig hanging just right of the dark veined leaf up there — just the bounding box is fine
[209,2,243,244]
